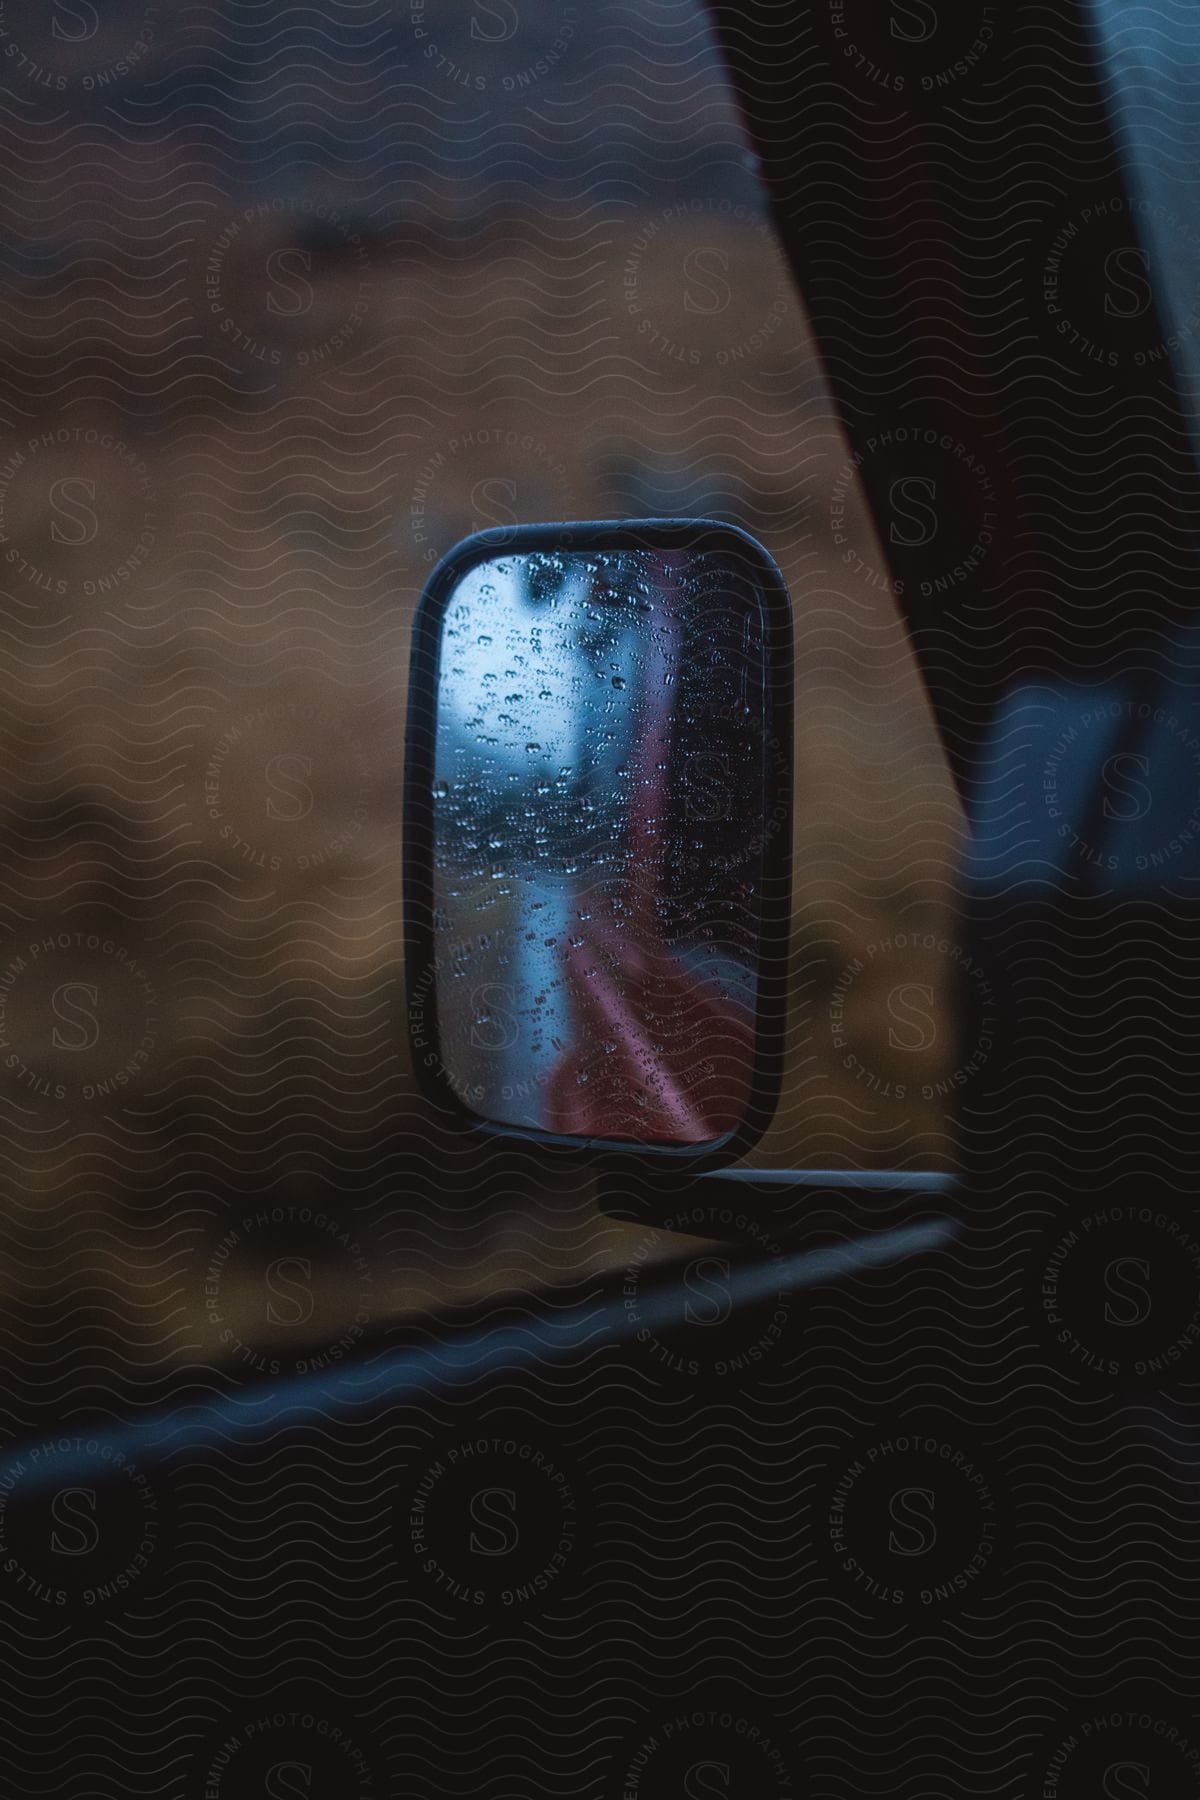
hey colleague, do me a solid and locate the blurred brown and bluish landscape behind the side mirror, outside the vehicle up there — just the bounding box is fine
[0,0,964,1389]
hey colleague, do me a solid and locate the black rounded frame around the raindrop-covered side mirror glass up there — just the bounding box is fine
[403,518,795,1174]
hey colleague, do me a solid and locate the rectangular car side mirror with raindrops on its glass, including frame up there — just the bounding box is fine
[405,520,793,1168]
